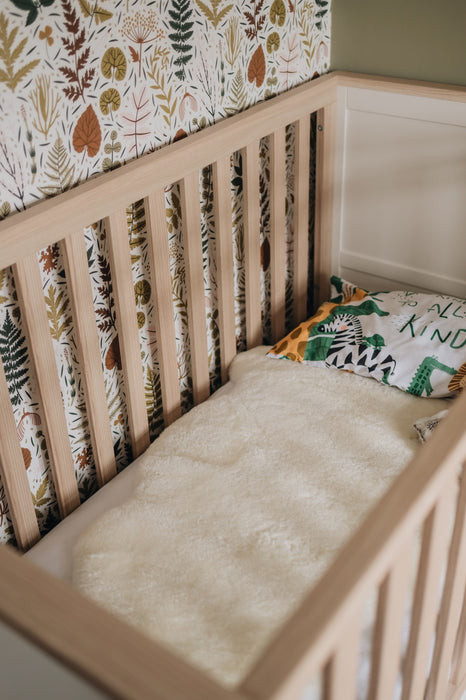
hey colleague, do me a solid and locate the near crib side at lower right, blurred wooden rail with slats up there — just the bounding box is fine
[240,388,466,700]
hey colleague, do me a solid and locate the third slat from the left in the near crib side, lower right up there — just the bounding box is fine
[402,478,456,700]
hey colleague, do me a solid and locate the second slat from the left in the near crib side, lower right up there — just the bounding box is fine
[369,548,411,700]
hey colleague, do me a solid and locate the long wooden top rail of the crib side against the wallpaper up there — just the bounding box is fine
[0,75,336,268]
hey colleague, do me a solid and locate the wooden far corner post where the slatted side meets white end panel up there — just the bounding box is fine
[314,102,336,305]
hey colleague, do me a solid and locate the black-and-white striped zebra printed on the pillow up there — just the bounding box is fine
[303,313,396,384]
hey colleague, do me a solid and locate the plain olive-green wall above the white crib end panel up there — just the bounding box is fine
[331,0,466,85]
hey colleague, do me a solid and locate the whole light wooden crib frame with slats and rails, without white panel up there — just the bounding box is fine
[0,73,466,700]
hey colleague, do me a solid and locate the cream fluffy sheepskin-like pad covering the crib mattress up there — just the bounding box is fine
[73,348,445,685]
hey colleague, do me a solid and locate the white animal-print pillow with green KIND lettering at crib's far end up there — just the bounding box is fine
[268,277,466,397]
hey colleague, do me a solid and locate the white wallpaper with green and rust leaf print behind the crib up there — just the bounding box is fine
[0,0,330,541]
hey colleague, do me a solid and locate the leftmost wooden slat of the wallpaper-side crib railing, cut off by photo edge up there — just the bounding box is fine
[0,359,39,551]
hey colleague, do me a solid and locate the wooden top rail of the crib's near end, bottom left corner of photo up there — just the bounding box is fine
[0,547,248,700]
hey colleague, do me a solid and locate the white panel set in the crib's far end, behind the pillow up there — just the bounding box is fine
[335,89,466,296]
